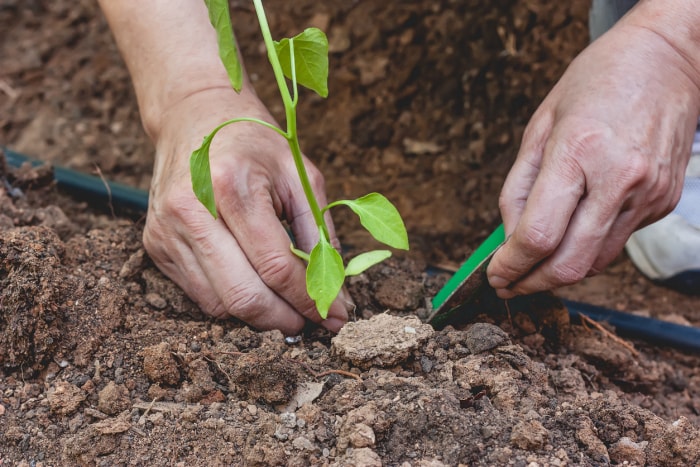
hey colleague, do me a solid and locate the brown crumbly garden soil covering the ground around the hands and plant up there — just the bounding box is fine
[0,0,700,466]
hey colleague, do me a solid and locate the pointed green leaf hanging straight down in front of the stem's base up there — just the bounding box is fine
[306,232,345,319]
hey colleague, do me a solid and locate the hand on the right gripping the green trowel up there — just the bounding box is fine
[488,18,700,298]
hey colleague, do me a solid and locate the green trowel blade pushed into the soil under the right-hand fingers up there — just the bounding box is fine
[428,224,506,324]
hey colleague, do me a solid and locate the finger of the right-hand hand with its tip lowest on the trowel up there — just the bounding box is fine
[487,135,585,290]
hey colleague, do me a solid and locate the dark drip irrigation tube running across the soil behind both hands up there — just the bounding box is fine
[2,147,700,352]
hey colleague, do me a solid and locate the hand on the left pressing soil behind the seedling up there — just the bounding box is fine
[144,88,352,334]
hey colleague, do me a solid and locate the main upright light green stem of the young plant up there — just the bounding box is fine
[253,0,330,241]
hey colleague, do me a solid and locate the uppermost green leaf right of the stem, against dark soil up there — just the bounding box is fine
[274,28,328,97]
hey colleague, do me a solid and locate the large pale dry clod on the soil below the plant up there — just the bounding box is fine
[331,313,434,368]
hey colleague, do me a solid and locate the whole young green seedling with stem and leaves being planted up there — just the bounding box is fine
[190,0,408,318]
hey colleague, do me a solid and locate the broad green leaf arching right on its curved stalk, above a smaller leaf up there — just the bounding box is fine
[323,193,408,250]
